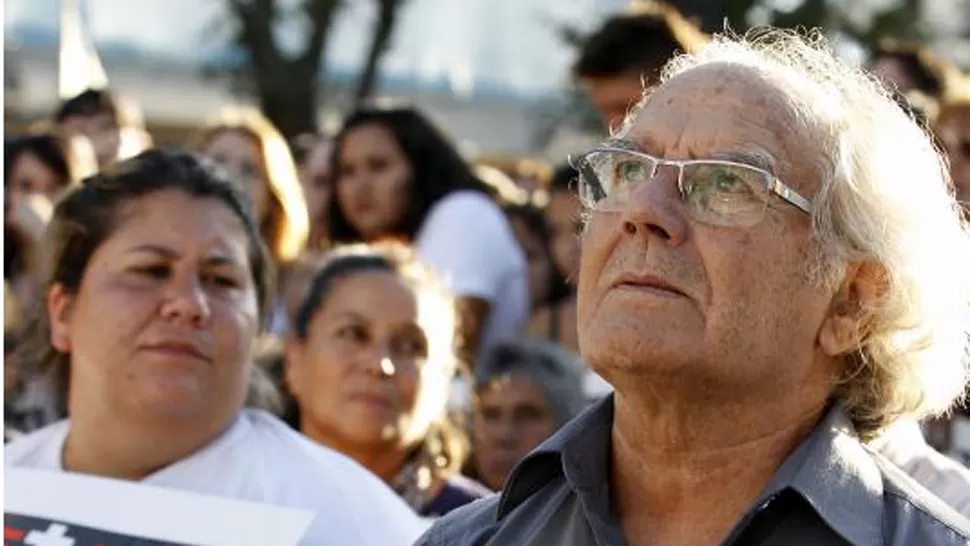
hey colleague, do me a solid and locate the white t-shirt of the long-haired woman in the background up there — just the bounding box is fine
[414,191,530,349]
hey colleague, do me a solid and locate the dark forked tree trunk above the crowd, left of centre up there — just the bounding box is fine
[226,0,406,137]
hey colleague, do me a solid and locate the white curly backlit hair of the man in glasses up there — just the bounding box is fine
[620,29,970,438]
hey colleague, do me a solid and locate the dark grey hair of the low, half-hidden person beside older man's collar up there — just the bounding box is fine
[475,339,586,427]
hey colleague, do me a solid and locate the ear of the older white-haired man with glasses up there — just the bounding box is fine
[818,262,887,356]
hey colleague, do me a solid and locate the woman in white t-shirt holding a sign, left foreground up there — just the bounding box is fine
[4,150,426,546]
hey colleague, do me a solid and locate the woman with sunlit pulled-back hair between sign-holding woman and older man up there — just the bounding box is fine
[286,243,488,516]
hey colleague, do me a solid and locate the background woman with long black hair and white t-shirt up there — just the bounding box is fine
[329,108,529,356]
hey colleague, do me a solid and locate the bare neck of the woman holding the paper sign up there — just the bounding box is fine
[62,412,233,481]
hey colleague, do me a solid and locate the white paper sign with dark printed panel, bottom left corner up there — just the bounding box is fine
[3,467,313,546]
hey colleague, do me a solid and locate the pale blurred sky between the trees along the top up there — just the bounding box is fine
[3,0,604,93]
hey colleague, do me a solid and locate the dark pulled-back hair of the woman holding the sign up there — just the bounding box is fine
[21,149,274,410]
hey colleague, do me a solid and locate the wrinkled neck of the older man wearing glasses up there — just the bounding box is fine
[611,372,828,545]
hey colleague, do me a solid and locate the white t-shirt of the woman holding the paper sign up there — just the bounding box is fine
[4,410,428,546]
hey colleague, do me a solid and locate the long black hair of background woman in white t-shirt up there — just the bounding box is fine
[328,108,488,243]
